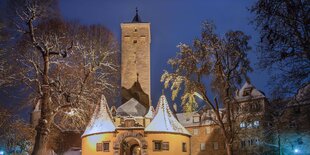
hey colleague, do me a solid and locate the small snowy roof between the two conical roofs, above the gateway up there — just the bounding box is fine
[116,98,146,116]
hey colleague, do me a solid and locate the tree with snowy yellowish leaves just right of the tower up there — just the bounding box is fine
[161,22,251,155]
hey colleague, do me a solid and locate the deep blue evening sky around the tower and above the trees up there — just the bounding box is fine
[60,0,269,104]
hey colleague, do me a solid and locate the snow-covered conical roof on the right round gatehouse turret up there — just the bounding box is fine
[145,95,191,136]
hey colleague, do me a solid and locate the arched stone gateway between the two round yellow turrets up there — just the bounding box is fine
[113,132,147,155]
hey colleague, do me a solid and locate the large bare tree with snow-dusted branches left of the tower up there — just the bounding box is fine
[4,0,118,155]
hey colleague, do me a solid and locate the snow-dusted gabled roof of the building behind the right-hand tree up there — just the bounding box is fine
[235,82,265,101]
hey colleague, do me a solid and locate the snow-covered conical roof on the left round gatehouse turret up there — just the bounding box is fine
[82,95,115,137]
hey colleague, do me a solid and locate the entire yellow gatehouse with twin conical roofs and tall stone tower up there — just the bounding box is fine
[82,9,191,155]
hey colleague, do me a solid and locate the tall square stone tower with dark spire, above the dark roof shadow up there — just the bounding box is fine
[121,9,151,100]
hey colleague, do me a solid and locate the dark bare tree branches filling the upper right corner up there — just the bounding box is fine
[250,0,310,97]
